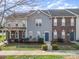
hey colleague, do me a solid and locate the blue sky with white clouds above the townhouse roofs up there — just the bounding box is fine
[0,0,79,11]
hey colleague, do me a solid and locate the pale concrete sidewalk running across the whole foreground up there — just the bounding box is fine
[0,50,79,55]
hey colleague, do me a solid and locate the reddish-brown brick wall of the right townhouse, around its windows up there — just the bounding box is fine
[52,17,76,40]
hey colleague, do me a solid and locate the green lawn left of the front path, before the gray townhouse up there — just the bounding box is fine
[1,43,41,50]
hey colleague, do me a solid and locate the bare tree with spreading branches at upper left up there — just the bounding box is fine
[0,0,35,27]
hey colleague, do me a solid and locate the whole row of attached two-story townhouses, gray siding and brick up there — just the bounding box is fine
[0,9,79,42]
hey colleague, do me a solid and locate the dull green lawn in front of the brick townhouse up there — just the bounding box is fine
[53,43,79,50]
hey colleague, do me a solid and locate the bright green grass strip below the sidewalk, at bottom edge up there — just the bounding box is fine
[6,55,64,59]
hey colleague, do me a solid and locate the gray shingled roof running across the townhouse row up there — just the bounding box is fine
[5,9,79,17]
